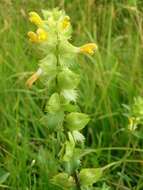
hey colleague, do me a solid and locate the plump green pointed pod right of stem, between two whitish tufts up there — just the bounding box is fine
[65,112,90,131]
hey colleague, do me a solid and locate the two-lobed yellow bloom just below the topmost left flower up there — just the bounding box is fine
[28,28,48,43]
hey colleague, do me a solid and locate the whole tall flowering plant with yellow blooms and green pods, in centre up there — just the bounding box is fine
[26,9,102,190]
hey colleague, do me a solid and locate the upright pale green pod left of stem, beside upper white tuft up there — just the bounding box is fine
[45,93,61,113]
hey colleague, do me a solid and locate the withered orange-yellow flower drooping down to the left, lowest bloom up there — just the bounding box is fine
[26,68,42,88]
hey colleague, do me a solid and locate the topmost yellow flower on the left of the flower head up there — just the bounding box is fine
[29,12,43,26]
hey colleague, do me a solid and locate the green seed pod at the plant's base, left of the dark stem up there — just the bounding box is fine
[51,173,75,190]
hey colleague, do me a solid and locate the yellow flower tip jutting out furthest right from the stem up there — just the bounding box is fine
[80,43,97,55]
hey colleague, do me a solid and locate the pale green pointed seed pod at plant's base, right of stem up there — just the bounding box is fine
[79,168,103,186]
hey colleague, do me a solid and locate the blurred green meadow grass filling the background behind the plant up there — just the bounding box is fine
[0,0,143,190]
